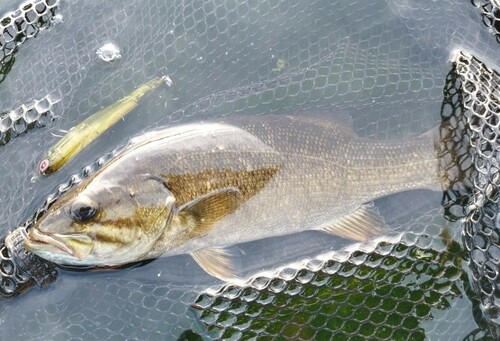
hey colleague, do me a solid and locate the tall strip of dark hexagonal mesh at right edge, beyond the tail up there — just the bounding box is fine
[455,52,500,337]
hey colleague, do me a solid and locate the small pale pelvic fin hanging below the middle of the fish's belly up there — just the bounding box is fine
[191,247,235,282]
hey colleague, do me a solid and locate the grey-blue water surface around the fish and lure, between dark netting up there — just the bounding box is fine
[0,0,494,339]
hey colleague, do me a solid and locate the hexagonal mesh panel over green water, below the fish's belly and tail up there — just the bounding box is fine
[195,210,465,340]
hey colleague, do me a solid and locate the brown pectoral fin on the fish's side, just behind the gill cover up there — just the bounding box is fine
[177,187,242,237]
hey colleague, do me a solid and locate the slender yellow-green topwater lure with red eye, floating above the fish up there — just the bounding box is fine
[38,76,172,175]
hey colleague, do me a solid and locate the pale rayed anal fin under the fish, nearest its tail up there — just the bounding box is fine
[320,204,386,241]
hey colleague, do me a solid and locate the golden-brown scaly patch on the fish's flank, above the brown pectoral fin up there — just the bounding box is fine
[161,165,281,205]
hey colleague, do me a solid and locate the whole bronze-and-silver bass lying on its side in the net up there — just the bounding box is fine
[25,114,446,281]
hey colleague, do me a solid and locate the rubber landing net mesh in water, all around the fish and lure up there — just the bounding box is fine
[0,0,500,340]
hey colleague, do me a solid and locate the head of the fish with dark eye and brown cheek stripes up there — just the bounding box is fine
[25,174,175,267]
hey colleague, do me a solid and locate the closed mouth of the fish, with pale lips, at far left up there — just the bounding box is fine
[24,228,94,260]
